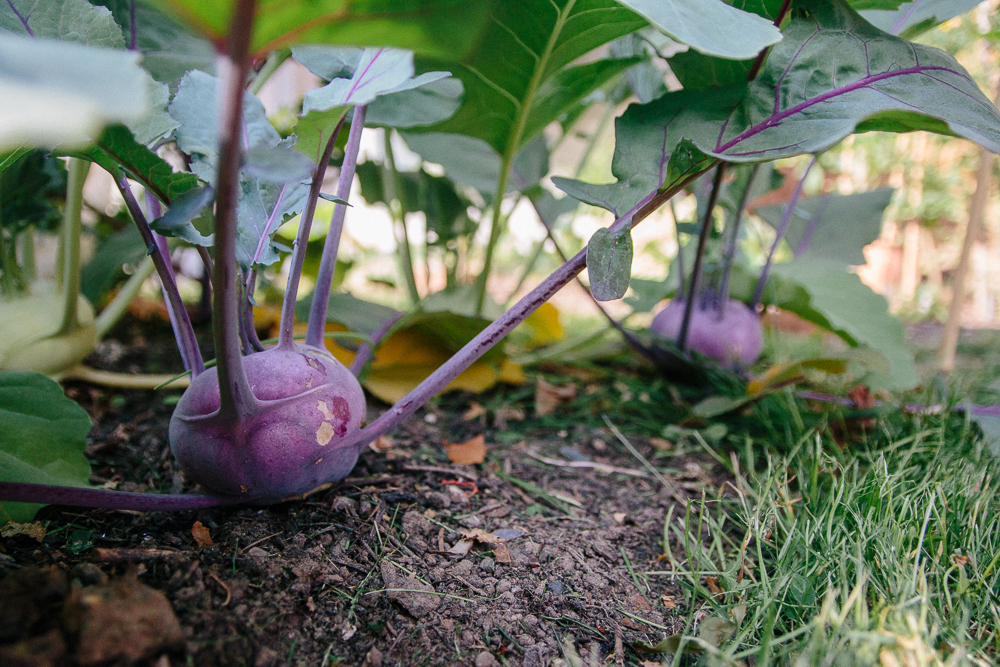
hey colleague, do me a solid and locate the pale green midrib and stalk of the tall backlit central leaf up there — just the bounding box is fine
[475,0,576,316]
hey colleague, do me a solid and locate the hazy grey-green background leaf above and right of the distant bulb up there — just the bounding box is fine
[755,188,894,266]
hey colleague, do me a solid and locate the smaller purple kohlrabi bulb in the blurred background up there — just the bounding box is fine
[650,299,764,366]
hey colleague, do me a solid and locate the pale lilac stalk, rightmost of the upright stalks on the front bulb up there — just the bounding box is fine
[306,105,367,347]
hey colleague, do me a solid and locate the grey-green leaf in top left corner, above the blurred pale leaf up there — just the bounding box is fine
[0,0,125,48]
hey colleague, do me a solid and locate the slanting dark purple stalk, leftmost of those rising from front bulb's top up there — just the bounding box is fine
[115,175,205,377]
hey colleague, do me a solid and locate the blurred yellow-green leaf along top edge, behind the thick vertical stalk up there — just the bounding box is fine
[144,0,493,57]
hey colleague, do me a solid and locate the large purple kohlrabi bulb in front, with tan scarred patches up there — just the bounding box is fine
[169,344,365,503]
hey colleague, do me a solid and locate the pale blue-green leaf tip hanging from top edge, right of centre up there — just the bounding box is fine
[620,0,781,59]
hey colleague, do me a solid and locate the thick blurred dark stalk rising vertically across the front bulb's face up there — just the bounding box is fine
[212,0,257,420]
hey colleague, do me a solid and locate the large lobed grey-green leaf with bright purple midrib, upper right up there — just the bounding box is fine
[553,0,1000,212]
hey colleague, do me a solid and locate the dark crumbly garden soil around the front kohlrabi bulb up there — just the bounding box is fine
[0,325,725,667]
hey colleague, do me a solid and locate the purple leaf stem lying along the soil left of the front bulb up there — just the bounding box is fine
[0,482,253,512]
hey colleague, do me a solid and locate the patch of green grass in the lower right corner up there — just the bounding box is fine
[647,402,1000,667]
